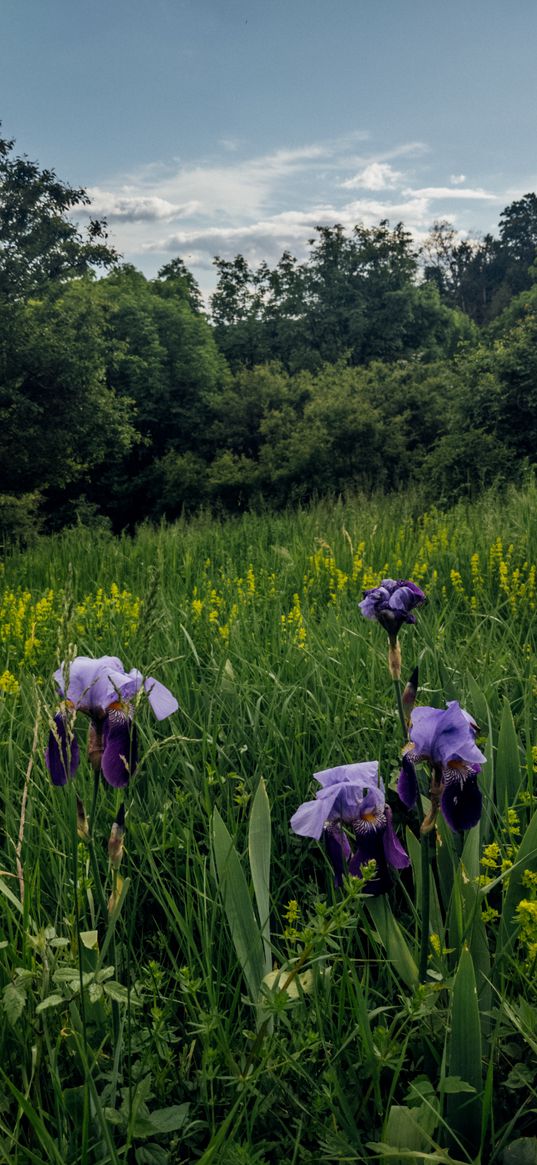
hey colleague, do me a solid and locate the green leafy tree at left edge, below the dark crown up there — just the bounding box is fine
[0,278,134,495]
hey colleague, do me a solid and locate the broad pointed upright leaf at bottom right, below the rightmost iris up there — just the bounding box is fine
[446,945,482,1153]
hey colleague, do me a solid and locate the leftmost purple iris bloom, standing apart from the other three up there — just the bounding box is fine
[45,656,178,789]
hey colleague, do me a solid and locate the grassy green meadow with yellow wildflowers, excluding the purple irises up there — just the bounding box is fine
[0,482,537,1165]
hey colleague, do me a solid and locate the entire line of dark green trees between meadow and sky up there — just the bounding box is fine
[0,128,537,537]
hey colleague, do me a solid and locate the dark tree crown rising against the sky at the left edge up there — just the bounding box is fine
[0,127,118,301]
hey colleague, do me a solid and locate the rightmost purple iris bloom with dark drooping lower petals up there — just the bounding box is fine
[397,700,487,831]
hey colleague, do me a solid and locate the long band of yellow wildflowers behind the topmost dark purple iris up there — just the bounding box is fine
[184,509,537,657]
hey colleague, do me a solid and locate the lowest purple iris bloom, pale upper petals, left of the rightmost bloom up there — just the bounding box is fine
[291,761,410,894]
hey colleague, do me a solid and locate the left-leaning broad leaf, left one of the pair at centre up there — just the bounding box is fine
[212,809,264,1004]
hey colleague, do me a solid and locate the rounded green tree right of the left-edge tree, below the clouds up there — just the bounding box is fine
[86,266,227,525]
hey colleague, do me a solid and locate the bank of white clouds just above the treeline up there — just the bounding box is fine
[80,132,521,294]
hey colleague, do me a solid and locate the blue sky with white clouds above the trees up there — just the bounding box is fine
[0,0,537,296]
